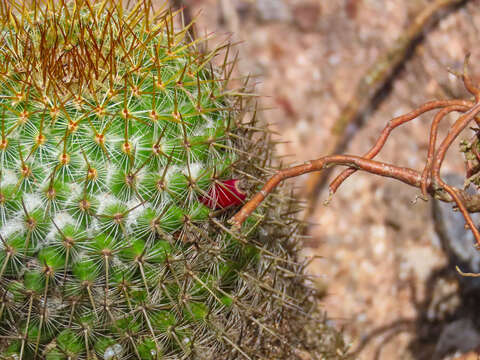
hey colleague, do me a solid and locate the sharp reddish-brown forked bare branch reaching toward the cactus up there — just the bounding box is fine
[229,56,480,247]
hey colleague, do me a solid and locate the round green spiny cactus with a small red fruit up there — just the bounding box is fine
[0,0,343,360]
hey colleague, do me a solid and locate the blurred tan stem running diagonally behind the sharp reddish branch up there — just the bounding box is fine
[304,0,470,226]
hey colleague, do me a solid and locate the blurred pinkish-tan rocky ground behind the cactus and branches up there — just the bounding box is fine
[170,0,480,360]
